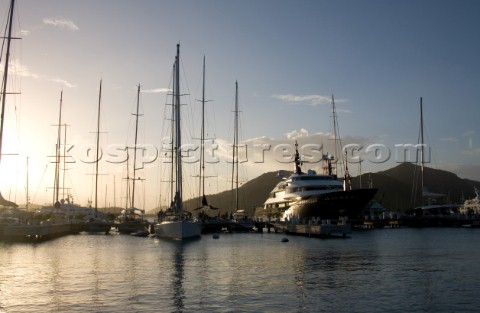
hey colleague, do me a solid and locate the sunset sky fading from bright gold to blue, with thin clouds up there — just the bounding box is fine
[0,0,480,210]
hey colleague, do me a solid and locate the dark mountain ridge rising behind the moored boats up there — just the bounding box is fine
[149,163,480,216]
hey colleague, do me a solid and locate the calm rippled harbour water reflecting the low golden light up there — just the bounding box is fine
[0,228,480,312]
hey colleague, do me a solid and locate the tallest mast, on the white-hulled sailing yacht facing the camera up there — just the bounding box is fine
[174,44,183,213]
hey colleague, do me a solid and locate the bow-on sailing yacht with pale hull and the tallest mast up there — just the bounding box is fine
[155,44,202,240]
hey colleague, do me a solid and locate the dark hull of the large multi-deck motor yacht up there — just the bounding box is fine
[289,189,377,219]
